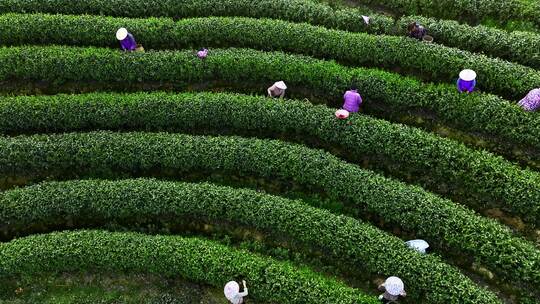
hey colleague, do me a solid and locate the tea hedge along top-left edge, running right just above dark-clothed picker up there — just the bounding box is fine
[0,0,540,68]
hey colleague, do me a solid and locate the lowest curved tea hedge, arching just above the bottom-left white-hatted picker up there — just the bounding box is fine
[0,231,377,304]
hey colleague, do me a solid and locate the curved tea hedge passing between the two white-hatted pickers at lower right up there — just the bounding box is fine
[0,180,499,303]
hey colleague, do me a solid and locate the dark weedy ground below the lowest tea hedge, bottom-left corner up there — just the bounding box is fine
[0,272,236,304]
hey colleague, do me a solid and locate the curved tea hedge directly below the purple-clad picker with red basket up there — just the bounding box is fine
[0,93,540,227]
